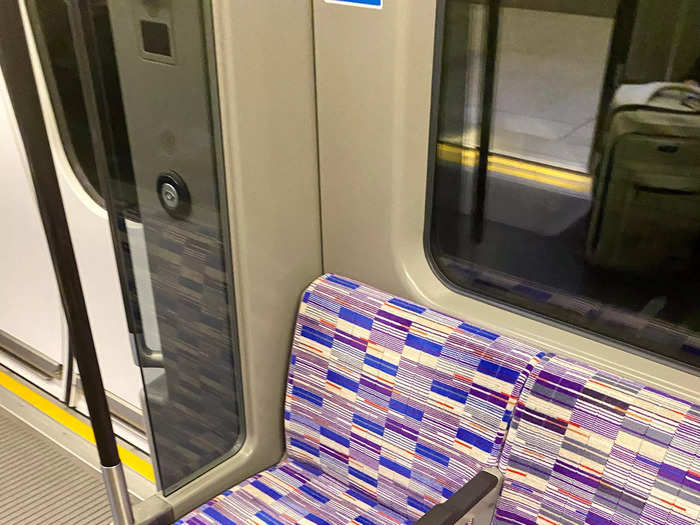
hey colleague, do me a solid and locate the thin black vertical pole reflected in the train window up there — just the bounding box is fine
[471,0,501,243]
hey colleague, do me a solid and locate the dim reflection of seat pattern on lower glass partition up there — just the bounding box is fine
[144,212,239,487]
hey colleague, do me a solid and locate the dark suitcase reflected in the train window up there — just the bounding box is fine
[587,82,700,275]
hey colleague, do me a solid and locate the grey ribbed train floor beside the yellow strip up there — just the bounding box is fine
[0,366,155,525]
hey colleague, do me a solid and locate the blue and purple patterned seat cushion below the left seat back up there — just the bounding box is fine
[176,460,410,525]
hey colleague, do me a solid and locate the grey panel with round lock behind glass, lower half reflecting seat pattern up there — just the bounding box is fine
[108,0,242,488]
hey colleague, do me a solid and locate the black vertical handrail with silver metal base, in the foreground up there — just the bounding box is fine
[0,0,134,525]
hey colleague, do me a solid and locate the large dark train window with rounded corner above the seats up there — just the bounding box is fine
[426,0,700,366]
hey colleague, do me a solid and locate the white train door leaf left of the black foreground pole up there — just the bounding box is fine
[0,62,71,401]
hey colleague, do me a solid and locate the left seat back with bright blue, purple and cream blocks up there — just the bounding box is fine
[285,275,544,518]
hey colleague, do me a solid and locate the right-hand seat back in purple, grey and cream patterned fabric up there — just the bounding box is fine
[493,356,700,525]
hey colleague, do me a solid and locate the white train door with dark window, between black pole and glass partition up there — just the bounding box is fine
[21,0,148,450]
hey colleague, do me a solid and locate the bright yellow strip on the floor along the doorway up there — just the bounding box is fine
[0,366,155,482]
